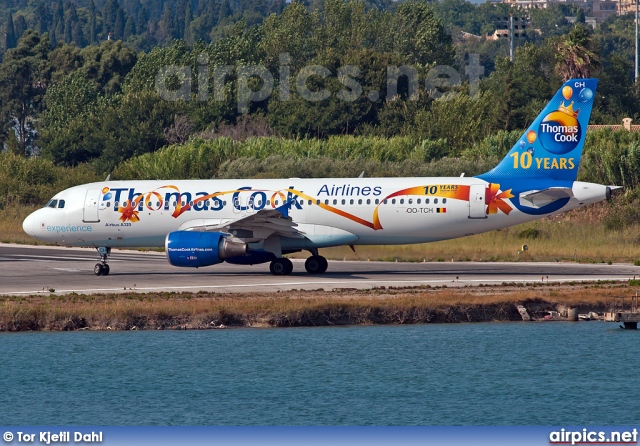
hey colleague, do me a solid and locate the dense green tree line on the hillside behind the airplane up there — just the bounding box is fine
[0,0,640,174]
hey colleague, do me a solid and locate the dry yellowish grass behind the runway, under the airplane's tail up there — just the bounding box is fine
[299,204,640,263]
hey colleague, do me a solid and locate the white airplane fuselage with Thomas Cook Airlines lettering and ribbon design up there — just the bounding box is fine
[23,177,607,250]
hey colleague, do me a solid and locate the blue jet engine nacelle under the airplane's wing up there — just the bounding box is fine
[165,231,247,268]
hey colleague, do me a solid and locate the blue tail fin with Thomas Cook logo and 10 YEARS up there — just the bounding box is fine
[479,79,598,183]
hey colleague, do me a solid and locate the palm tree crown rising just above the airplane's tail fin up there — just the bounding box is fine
[556,23,601,81]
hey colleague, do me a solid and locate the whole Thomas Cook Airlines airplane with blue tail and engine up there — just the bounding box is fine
[23,79,615,276]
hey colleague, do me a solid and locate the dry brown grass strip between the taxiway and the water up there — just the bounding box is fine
[0,284,635,331]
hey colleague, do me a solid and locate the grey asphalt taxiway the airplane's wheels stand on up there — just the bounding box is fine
[0,244,640,295]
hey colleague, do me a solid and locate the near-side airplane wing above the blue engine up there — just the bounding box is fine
[178,203,304,243]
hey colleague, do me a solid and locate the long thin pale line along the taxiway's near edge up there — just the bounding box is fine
[3,276,630,295]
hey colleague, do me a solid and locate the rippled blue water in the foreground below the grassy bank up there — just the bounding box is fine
[0,322,640,425]
